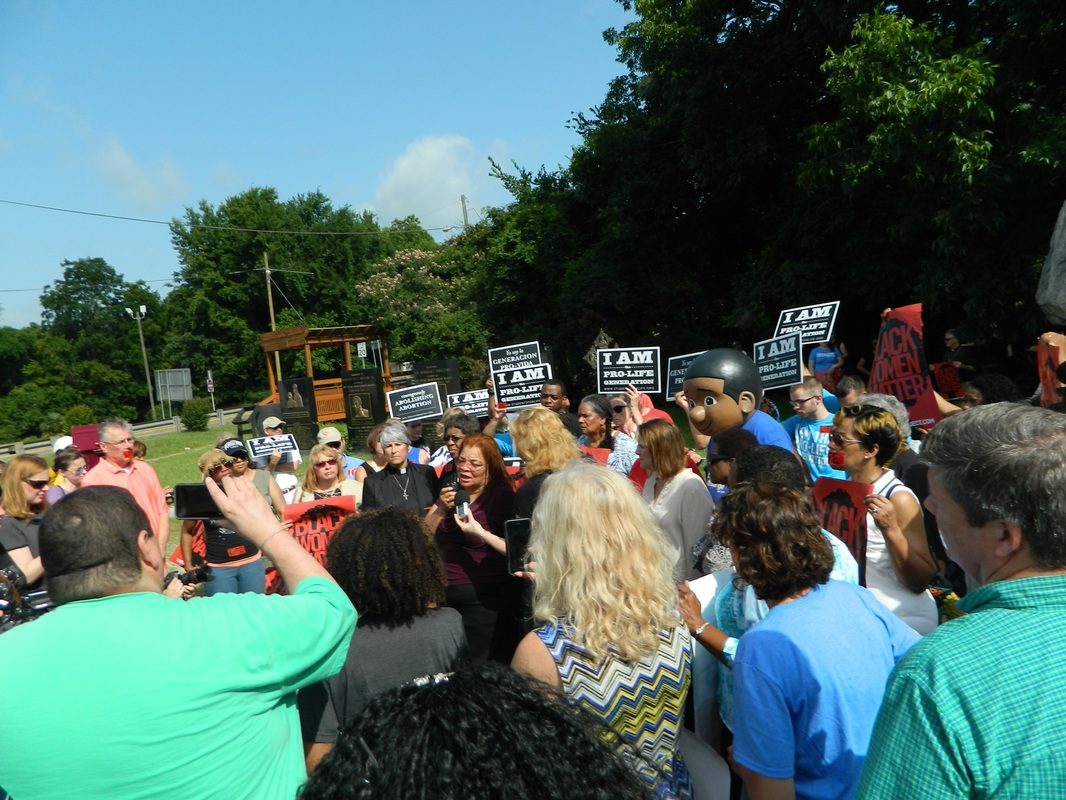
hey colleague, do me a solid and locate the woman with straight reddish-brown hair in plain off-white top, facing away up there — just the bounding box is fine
[636,419,714,582]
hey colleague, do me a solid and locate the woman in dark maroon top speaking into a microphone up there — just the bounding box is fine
[426,433,522,663]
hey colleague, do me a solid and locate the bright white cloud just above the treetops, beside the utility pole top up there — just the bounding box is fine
[374,134,477,227]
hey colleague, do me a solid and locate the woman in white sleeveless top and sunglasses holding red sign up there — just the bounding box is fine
[829,405,938,636]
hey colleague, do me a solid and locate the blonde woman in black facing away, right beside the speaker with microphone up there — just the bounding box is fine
[511,405,581,517]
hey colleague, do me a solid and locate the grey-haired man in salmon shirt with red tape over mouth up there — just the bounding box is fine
[81,417,171,562]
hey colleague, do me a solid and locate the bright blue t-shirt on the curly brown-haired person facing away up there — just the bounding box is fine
[733,580,919,798]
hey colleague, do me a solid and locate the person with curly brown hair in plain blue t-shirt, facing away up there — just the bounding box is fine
[713,483,918,800]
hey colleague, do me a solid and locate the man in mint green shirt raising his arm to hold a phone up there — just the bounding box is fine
[0,478,355,800]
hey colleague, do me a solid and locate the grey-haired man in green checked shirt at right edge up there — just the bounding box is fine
[856,403,1066,800]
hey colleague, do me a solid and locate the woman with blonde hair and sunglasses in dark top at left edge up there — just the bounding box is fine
[0,455,48,589]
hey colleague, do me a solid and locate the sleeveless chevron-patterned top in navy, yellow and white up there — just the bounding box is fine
[537,620,692,799]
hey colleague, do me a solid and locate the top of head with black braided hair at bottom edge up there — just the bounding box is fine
[301,663,645,800]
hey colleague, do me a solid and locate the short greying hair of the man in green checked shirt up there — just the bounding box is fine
[922,402,1066,570]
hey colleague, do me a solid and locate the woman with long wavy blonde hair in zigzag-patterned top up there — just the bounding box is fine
[512,461,692,798]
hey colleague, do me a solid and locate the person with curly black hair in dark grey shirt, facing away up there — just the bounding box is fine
[297,507,466,771]
